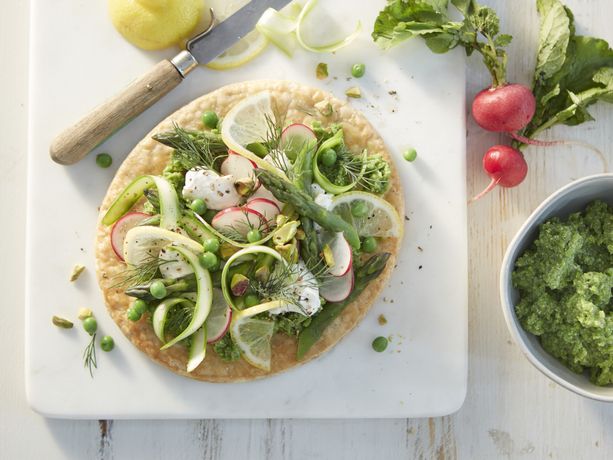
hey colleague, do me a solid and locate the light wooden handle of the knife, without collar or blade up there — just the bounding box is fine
[49,60,183,165]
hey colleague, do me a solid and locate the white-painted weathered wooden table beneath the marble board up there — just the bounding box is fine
[0,0,613,460]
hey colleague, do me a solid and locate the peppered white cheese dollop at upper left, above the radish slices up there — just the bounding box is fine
[183,169,241,211]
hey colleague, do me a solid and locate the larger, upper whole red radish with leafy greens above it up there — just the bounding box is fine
[472,84,536,133]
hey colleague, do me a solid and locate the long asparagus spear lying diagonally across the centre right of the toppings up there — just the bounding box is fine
[255,169,360,249]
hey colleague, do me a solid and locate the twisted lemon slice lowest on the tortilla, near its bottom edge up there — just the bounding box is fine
[230,300,283,372]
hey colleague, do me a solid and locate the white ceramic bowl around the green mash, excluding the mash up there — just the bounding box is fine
[500,174,613,402]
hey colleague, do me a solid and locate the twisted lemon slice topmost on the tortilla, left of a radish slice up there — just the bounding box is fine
[221,91,283,174]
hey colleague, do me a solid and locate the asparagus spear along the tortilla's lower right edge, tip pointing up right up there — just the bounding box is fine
[296,252,390,360]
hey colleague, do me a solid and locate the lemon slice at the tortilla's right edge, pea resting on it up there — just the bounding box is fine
[332,192,403,238]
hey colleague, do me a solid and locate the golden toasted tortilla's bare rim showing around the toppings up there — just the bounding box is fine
[96,80,404,382]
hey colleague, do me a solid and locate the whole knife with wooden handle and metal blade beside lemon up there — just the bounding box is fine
[49,0,291,165]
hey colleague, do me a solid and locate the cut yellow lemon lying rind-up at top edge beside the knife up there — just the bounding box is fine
[108,0,204,50]
